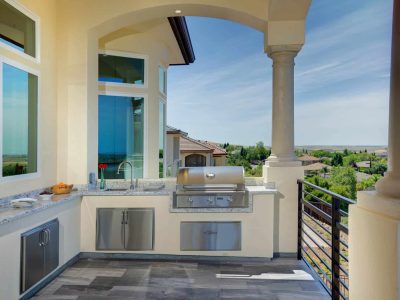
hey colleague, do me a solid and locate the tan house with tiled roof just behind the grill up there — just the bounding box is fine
[166,126,227,176]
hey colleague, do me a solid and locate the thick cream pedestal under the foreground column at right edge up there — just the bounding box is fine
[349,192,400,300]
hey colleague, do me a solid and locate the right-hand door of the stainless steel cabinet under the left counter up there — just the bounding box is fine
[43,220,59,275]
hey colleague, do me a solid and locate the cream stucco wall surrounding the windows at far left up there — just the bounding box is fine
[0,0,58,197]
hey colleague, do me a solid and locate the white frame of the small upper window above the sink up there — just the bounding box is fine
[97,49,149,89]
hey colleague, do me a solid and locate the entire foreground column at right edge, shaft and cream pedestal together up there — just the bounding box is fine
[348,0,400,300]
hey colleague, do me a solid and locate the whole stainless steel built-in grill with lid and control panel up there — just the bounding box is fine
[174,167,248,208]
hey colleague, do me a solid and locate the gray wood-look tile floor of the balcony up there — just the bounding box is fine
[33,258,330,300]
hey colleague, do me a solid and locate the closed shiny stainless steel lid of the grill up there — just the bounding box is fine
[177,166,244,187]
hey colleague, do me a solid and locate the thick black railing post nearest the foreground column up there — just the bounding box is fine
[332,196,340,300]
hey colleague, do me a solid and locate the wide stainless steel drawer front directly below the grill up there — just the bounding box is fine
[180,221,242,251]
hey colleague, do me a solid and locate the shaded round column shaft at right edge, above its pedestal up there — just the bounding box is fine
[376,0,400,198]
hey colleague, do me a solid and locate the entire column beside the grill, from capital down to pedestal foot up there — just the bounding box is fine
[263,45,304,254]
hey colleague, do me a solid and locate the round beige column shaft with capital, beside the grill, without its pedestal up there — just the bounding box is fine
[266,45,301,166]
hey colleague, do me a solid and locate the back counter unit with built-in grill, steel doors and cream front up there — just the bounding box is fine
[81,167,276,258]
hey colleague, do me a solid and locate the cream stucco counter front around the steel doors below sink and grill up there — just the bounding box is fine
[81,194,275,257]
